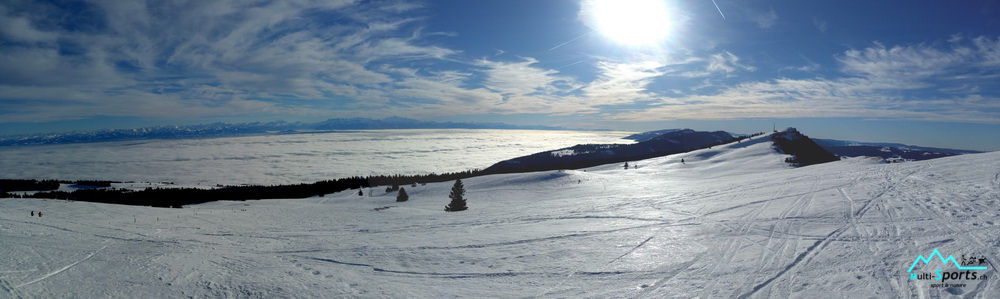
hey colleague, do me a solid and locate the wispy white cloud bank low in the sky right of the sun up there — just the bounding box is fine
[607,37,1000,124]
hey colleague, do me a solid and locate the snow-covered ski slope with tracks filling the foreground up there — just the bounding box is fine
[0,138,1000,298]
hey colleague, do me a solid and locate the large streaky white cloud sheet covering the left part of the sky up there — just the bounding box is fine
[0,1,457,121]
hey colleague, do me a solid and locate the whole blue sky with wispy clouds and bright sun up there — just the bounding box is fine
[0,0,1000,150]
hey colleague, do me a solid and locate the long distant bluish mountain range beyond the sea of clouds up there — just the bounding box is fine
[0,117,568,146]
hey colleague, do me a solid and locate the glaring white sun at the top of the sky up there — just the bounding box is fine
[581,0,673,46]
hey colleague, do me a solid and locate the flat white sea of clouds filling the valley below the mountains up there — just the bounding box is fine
[0,130,631,186]
